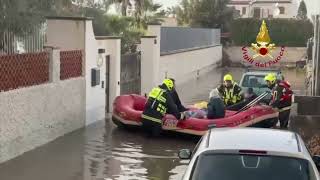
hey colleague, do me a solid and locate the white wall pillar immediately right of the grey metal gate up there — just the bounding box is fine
[141,36,160,95]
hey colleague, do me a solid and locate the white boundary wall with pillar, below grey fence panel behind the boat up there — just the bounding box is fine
[141,25,222,95]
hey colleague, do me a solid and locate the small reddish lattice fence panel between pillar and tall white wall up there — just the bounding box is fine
[60,50,83,80]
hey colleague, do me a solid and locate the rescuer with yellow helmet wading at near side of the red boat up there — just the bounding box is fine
[141,79,185,136]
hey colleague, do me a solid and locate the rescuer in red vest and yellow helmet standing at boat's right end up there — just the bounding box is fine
[264,73,293,129]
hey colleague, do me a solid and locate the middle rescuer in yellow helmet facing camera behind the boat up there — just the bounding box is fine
[218,74,242,107]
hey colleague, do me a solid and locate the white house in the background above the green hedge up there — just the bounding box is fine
[228,0,299,18]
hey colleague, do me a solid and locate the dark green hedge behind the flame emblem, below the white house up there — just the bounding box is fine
[231,18,313,47]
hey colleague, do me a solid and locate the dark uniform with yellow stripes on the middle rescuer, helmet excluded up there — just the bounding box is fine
[218,82,242,107]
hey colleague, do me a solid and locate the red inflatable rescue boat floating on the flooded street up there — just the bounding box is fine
[112,95,278,135]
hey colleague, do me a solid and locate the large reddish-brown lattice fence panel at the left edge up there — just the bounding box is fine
[0,52,49,91]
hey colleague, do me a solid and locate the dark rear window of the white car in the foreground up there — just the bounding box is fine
[191,154,312,180]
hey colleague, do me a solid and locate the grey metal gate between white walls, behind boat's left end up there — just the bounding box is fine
[120,52,141,95]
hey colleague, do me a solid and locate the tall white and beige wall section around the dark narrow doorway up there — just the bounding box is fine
[47,17,121,125]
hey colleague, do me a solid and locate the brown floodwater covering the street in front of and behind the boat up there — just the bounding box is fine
[0,68,305,180]
